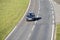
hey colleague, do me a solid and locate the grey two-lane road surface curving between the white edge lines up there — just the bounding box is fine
[6,0,53,40]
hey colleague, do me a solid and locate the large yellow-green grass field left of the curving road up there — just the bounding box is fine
[0,0,29,40]
